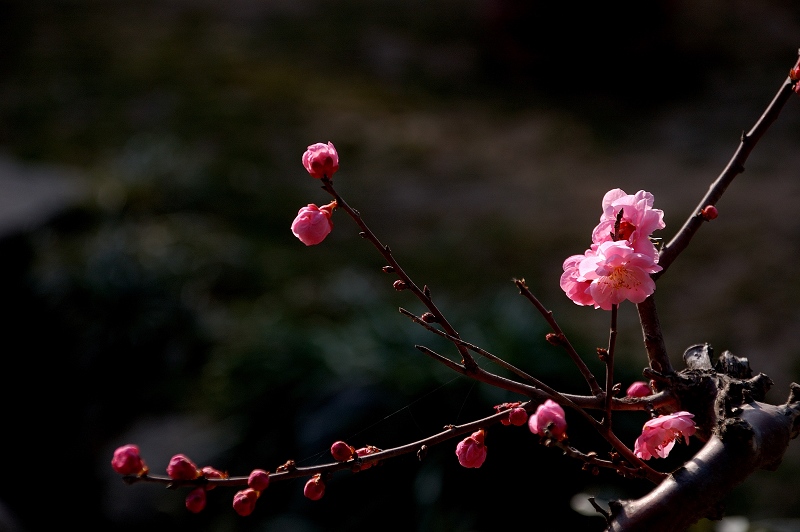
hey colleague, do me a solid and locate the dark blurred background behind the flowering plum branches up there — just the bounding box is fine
[0,0,800,531]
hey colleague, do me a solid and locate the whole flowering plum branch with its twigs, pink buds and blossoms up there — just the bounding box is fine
[112,51,800,532]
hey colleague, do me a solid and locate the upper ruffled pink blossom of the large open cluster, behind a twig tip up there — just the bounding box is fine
[592,188,666,260]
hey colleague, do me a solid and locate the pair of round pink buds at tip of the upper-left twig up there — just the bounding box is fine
[292,142,339,246]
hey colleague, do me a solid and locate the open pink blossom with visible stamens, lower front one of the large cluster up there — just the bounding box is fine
[573,241,662,310]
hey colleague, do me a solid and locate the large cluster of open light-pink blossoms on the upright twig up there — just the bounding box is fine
[561,188,665,310]
